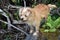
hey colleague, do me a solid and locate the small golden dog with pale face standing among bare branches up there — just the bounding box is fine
[19,4,56,36]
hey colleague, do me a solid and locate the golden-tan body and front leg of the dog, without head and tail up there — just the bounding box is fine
[27,4,50,31]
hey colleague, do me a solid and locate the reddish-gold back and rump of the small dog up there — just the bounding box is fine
[33,4,50,18]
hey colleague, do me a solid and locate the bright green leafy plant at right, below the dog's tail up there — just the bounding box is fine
[43,15,60,32]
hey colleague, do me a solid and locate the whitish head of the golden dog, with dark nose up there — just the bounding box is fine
[19,7,31,21]
